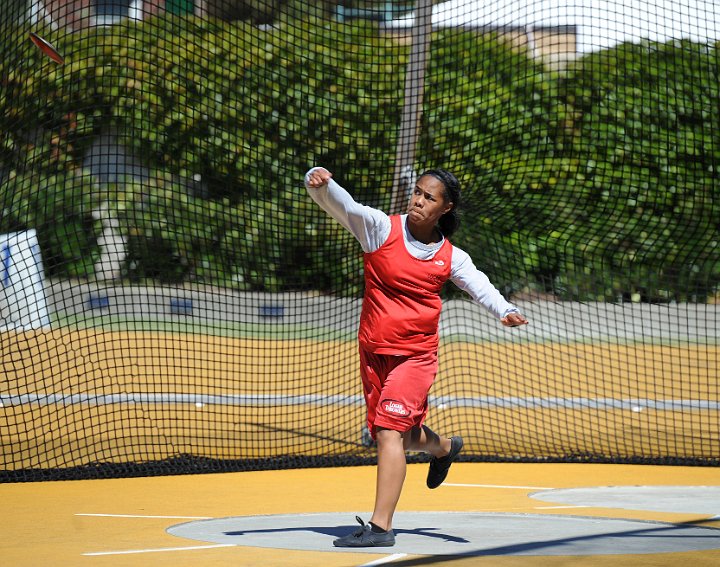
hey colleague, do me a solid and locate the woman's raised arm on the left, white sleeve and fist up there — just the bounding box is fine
[305,167,390,252]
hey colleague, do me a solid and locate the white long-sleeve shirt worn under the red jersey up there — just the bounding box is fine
[305,169,517,318]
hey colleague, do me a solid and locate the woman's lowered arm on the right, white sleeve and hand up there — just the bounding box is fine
[450,246,528,327]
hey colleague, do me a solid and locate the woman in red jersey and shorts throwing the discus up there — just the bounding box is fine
[305,167,528,547]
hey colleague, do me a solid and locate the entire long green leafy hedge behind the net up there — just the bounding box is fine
[0,18,720,301]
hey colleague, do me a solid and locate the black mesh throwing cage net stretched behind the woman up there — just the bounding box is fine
[0,0,720,481]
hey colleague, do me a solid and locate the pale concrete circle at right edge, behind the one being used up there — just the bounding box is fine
[530,486,720,516]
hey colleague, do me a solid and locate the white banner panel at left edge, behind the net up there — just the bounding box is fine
[0,229,50,330]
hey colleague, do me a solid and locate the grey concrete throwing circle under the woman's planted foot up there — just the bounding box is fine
[167,512,720,556]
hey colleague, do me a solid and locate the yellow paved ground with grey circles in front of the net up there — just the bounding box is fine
[0,463,720,567]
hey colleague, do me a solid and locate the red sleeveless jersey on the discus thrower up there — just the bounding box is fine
[358,215,452,356]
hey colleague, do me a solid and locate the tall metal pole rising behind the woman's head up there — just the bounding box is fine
[390,0,432,213]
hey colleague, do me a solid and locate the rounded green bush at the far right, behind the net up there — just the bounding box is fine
[563,41,720,301]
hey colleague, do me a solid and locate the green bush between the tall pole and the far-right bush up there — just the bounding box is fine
[419,31,569,293]
